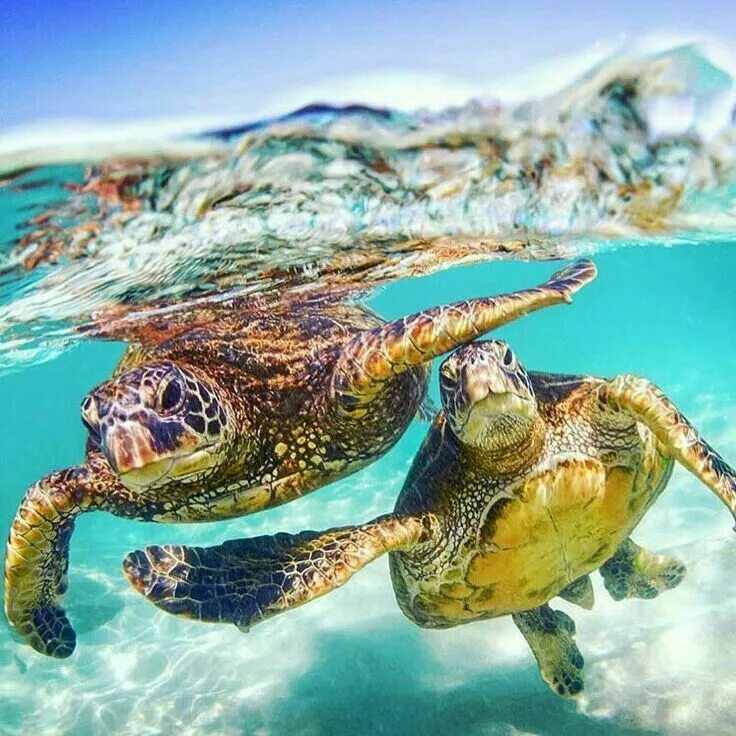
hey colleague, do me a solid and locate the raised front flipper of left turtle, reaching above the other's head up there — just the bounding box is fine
[332,260,596,411]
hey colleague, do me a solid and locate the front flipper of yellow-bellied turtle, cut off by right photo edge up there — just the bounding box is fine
[599,375,736,519]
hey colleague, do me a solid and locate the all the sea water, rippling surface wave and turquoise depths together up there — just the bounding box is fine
[0,46,736,736]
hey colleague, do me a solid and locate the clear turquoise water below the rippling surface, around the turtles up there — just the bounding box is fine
[0,243,736,735]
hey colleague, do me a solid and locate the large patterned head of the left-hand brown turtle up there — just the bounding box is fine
[82,362,227,491]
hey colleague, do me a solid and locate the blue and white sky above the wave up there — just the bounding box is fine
[0,0,736,135]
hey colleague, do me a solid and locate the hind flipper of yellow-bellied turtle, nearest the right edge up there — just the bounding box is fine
[600,539,686,601]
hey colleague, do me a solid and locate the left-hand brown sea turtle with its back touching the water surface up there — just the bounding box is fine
[5,260,595,657]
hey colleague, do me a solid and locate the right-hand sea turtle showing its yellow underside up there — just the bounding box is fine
[124,340,736,696]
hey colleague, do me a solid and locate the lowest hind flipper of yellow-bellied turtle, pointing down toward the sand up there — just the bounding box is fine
[513,605,584,698]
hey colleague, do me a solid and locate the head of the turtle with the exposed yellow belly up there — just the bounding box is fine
[440,340,538,451]
